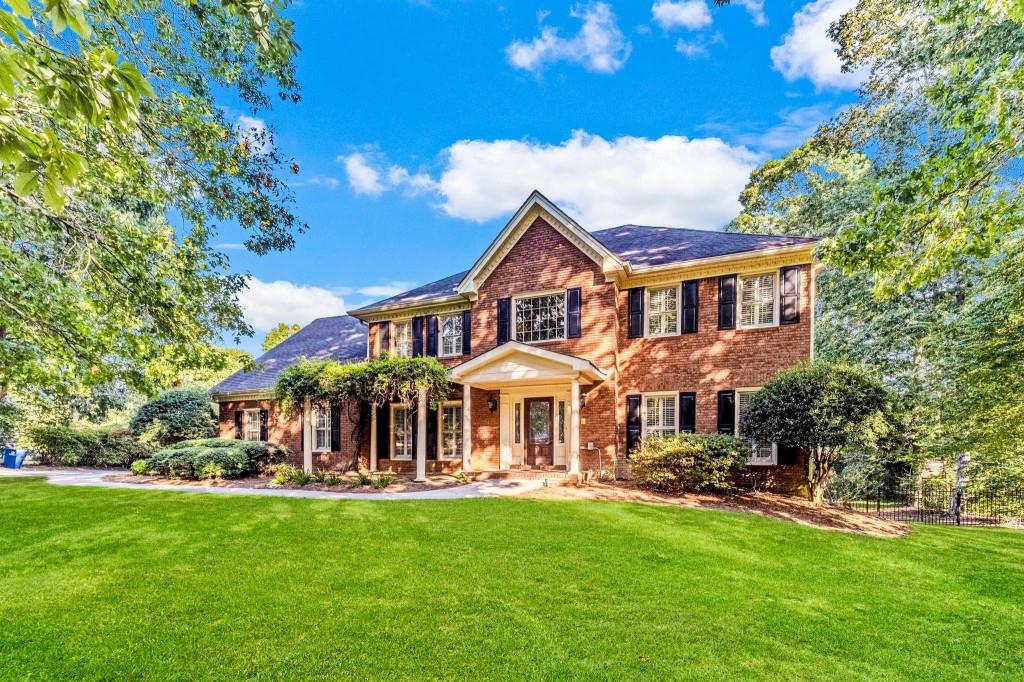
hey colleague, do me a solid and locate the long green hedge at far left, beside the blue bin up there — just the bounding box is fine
[26,424,152,467]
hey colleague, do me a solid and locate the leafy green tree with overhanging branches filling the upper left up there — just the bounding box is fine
[0,0,303,403]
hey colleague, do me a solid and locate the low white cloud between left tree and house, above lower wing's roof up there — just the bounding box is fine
[239,278,345,332]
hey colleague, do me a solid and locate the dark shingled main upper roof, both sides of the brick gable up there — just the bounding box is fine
[352,225,817,313]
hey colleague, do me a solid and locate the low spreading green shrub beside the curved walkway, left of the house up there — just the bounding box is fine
[138,438,288,478]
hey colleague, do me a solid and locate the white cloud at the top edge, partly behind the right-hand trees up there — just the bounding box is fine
[771,0,863,89]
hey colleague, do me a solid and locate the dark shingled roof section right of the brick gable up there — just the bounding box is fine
[591,225,816,267]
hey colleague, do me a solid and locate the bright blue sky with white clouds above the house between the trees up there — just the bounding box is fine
[218,0,857,352]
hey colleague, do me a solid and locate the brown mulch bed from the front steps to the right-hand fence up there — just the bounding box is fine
[525,481,910,538]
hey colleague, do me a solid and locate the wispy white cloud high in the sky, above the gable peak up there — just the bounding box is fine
[505,2,632,74]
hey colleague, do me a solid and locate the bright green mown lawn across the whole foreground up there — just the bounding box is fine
[0,479,1024,680]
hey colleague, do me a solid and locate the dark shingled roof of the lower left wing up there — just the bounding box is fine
[210,315,367,394]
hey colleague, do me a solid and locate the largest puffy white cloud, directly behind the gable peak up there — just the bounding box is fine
[438,131,760,229]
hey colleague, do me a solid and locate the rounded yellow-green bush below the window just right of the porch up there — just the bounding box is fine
[631,433,750,493]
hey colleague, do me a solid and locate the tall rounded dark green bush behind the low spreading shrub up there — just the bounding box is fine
[128,389,217,445]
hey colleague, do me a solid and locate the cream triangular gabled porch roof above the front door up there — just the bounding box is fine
[451,341,607,388]
